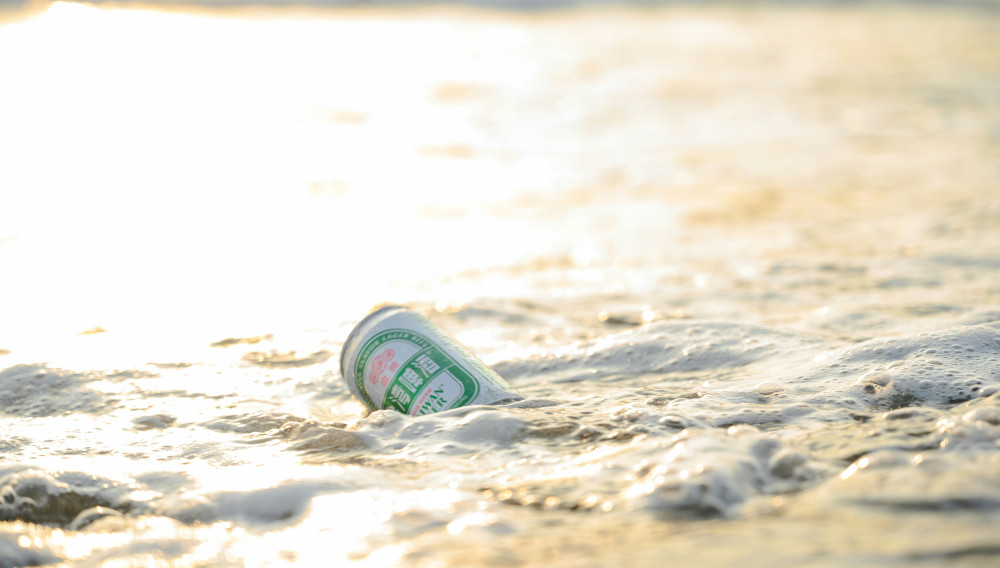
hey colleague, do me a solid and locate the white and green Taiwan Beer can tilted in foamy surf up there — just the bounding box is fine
[340,306,522,416]
